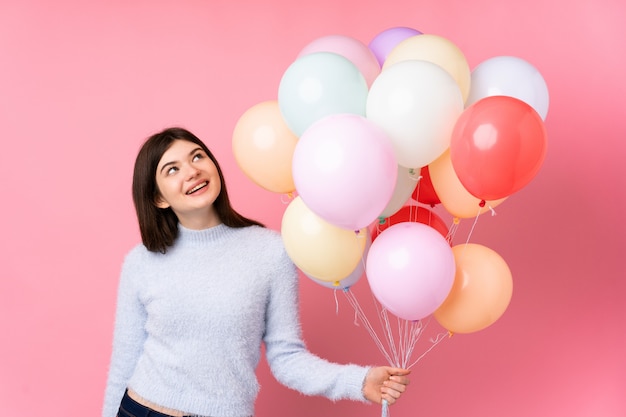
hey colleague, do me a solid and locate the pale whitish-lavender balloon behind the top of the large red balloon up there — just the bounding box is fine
[465,56,550,120]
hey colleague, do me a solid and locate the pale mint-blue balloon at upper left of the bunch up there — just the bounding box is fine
[278,52,368,137]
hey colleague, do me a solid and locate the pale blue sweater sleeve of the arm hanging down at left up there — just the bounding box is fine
[102,247,146,417]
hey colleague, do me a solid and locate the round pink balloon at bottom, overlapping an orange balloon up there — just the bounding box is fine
[365,222,456,320]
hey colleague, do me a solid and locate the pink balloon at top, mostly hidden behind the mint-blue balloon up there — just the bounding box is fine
[298,35,380,87]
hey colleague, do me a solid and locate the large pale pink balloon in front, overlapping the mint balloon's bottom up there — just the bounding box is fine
[292,114,398,230]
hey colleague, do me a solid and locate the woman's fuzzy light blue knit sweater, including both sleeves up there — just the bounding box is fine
[102,225,368,417]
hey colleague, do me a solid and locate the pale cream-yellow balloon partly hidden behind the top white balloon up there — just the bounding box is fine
[382,34,471,102]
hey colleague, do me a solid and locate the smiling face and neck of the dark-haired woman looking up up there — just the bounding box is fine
[156,140,222,229]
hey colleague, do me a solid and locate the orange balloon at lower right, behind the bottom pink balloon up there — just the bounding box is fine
[434,243,513,333]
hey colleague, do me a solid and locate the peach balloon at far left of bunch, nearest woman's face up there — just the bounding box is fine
[232,100,298,193]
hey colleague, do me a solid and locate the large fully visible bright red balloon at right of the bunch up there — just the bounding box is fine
[450,96,547,200]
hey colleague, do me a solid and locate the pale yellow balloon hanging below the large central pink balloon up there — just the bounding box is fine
[281,197,367,281]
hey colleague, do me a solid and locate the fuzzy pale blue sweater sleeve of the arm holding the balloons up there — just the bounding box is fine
[264,245,369,402]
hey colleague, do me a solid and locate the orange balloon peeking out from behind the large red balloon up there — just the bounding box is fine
[428,149,507,219]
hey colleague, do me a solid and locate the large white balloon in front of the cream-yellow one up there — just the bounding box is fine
[365,60,463,168]
